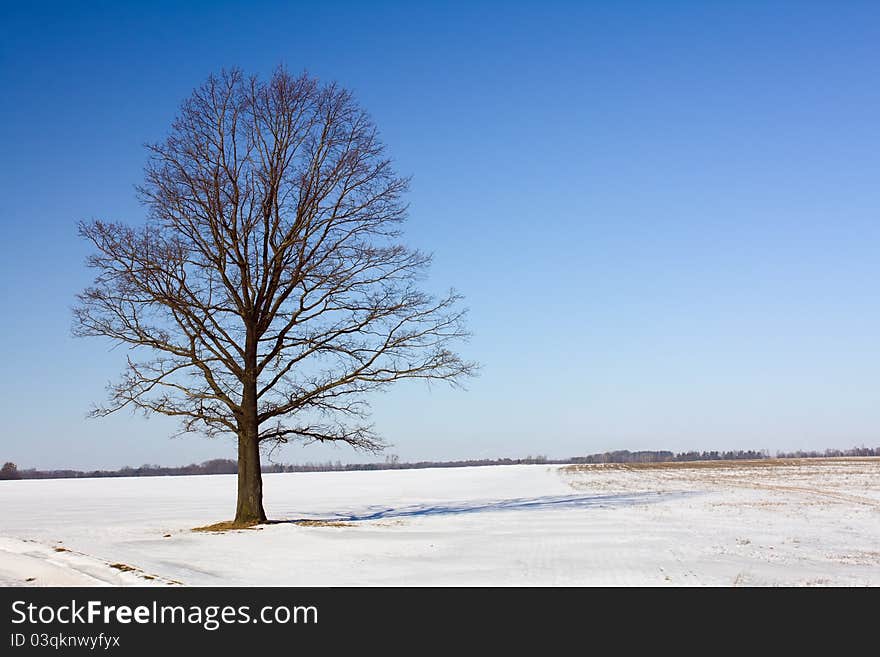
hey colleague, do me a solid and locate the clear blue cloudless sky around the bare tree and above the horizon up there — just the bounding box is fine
[0,0,880,468]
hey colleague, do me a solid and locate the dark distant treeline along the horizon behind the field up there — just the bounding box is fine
[0,447,880,479]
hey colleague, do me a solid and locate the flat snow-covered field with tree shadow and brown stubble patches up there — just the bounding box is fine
[0,459,880,586]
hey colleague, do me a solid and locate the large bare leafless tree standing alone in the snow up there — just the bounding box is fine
[74,69,475,525]
